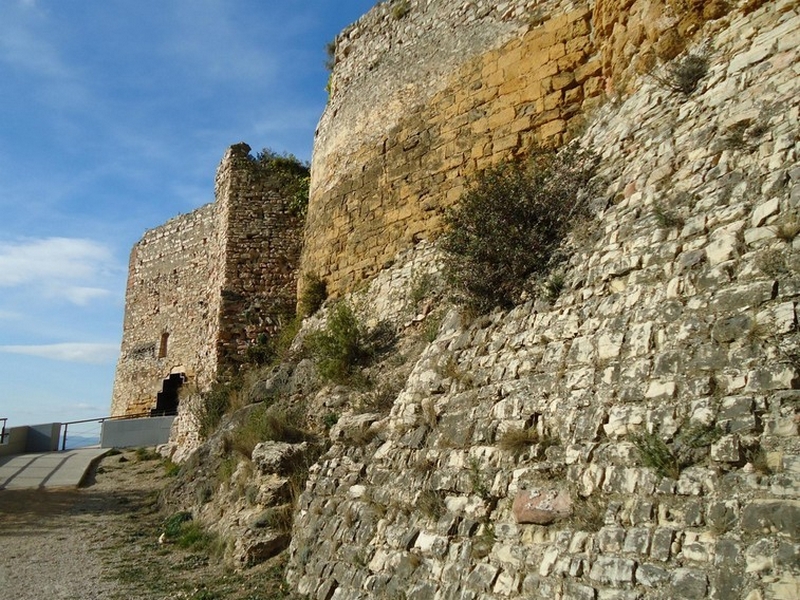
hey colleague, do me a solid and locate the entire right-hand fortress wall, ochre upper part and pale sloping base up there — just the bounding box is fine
[141,0,800,600]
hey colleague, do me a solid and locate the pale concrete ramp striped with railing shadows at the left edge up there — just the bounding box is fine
[0,448,109,490]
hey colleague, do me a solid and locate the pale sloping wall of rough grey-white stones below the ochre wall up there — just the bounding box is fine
[289,0,800,600]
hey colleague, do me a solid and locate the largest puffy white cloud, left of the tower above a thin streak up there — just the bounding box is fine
[0,237,117,305]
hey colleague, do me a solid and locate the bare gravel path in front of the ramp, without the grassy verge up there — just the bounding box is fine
[0,453,163,600]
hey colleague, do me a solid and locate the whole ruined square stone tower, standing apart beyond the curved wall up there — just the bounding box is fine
[112,144,302,415]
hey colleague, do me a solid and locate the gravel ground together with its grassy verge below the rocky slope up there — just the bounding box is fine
[0,451,298,600]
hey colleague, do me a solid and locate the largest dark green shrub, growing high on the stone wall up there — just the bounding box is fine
[441,146,596,312]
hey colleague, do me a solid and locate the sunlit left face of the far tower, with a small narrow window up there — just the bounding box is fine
[111,204,223,415]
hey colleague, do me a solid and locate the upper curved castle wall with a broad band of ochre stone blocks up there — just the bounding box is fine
[301,0,719,294]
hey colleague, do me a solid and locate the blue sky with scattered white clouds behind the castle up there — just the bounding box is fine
[0,0,375,425]
